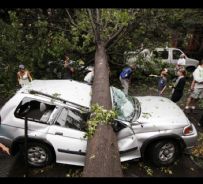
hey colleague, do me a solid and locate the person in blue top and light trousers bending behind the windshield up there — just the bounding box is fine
[119,64,136,95]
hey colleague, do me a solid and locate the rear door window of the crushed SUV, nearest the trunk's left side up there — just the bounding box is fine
[55,108,89,131]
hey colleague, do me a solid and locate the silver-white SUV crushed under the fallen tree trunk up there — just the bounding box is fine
[0,80,197,167]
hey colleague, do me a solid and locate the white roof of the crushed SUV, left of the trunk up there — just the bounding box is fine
[19,79,92,108]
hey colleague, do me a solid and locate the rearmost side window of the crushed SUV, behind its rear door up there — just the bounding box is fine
[14,98,56,123]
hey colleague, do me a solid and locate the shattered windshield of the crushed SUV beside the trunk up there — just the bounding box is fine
[112,87,136,121]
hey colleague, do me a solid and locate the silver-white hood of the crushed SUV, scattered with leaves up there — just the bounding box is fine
[136,96,189,126]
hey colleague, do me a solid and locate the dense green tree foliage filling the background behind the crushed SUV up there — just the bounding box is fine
[0,8,203,98]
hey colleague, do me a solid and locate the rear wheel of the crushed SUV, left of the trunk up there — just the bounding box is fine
[27,142,53,167]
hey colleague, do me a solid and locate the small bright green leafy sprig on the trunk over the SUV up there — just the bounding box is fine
[85,104,117,138]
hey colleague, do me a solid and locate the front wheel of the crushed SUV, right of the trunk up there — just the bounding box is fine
[149,140,180,166]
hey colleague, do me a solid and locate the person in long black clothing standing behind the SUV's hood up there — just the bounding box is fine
[171,68,186,102]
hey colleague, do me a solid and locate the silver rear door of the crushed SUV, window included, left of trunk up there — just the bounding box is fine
[47,108,87,166]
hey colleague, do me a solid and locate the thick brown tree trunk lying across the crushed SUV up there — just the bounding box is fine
[83,44,123,177]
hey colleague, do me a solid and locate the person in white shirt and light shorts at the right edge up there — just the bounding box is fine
[185,59,203,109]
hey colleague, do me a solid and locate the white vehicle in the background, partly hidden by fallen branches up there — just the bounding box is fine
[124,48,199,72]
